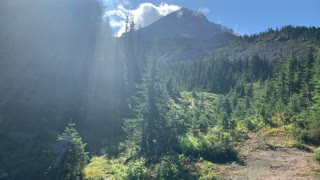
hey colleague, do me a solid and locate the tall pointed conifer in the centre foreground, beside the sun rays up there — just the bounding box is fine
[124,55,172,161]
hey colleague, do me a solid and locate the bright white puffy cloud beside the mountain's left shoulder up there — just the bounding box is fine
[105,0,180,37]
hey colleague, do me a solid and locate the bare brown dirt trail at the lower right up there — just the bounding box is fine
[217,133,320,180]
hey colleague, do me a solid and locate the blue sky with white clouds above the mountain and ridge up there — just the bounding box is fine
[102,0,320,36]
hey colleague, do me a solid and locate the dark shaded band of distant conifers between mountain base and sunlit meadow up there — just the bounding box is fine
[162,55,273,95]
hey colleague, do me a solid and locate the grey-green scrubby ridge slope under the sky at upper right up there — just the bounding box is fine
[212,25,320,60]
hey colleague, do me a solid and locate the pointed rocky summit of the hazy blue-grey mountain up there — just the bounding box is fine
[139,8,233,40]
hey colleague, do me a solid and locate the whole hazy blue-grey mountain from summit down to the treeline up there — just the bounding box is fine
[122,8,237,62]
